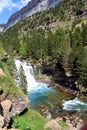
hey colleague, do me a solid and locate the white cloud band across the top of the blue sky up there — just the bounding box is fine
[0,0,30,14]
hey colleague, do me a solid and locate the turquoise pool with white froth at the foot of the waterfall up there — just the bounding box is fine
[28,83,54,107]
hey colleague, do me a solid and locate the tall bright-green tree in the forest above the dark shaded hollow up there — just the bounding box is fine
[52,27,68,66]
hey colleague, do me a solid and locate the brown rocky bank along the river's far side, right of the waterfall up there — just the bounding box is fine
[37,74,87,101]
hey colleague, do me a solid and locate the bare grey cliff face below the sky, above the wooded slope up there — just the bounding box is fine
[4,0,63,31]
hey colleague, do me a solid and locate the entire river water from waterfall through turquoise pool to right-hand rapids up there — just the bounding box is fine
[15,59,87,112]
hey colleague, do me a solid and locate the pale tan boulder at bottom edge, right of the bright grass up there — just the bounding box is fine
[44,119,61,130]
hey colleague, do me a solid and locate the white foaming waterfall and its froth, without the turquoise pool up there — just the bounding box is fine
[15,59,53,93]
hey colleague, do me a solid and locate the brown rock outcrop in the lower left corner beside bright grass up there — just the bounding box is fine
[0,96,28,130]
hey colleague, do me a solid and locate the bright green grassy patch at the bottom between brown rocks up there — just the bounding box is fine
[12,110,46,130]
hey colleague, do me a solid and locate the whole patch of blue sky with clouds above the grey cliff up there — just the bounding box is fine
[0,0,31,24]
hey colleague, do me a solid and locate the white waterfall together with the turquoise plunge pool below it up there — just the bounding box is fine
[15,59,53,106]
